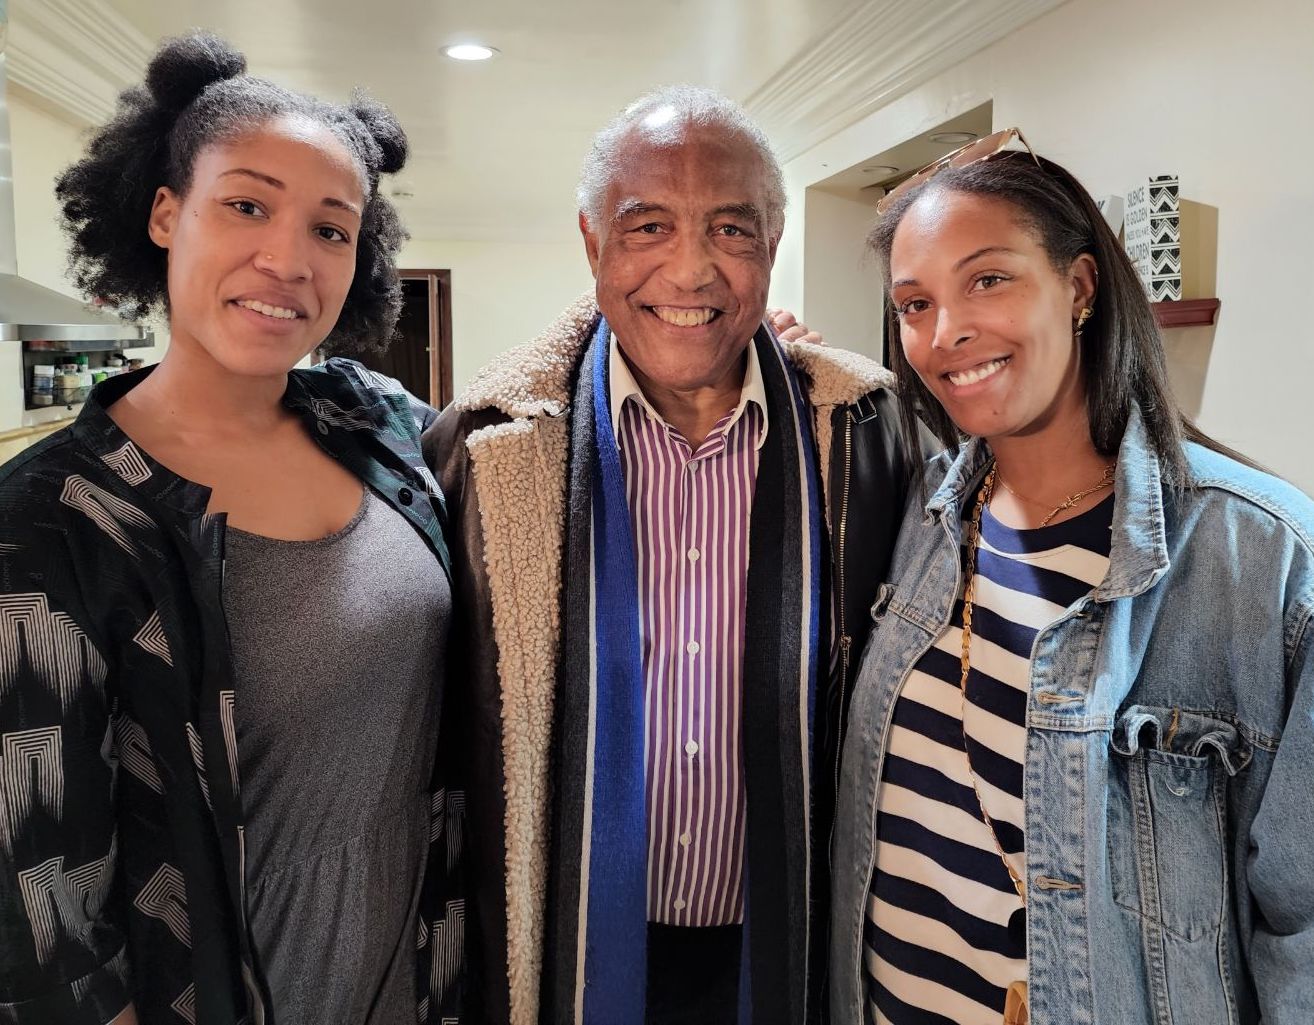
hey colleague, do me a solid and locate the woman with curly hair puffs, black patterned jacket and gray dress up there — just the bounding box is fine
[0,34,470,1025]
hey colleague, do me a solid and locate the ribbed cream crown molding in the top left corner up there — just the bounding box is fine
[7,0,154,125]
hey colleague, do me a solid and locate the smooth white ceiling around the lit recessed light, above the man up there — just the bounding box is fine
[112,0,846,240]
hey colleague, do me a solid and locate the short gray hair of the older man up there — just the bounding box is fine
[576,85,784,239]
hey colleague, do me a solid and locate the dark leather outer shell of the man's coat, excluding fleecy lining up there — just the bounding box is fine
[424,329,909,1022]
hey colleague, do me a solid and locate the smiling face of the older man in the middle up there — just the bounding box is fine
[579,118,778,392]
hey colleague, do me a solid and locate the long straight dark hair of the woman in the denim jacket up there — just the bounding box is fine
[867,152,1244,488]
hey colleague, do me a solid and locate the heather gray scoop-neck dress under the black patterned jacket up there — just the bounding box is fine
[223,488,451,1025]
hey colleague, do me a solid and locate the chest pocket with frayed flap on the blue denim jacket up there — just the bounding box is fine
[1108,704,1252,942]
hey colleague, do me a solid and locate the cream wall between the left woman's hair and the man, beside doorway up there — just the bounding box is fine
[398,237,593,394]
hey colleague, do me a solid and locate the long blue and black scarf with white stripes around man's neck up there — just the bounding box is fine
[541,321,824,1025]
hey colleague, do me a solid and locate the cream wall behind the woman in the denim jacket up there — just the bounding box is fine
[771,0,1314,491]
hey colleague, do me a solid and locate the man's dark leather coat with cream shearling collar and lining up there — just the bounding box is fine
[423,294,908,1025]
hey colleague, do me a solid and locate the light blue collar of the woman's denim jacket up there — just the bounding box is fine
[926,405,1168,602]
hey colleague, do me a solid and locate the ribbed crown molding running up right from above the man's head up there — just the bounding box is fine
[744,0,1066,163]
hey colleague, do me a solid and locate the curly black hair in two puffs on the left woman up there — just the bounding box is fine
[55,33,406,352]
